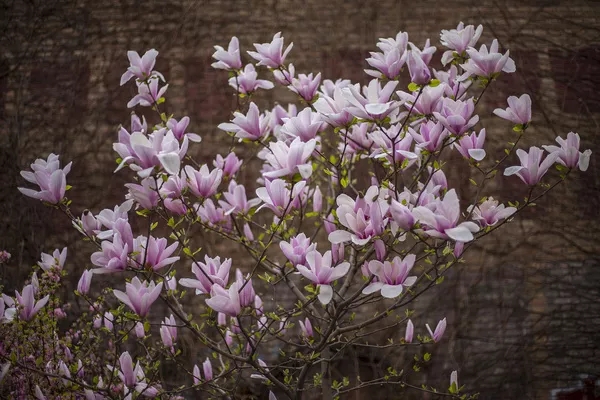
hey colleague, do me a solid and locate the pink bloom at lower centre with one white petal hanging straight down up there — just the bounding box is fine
[296,250,350,304]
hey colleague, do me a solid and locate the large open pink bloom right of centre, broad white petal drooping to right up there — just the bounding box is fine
[412,189,479,242]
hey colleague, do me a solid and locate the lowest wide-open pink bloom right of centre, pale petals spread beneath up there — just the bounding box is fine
[362,254,417,299]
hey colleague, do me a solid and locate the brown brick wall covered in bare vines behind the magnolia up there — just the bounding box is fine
[0,0,600,399]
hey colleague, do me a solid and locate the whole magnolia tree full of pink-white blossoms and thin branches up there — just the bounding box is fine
[0,23,591,400]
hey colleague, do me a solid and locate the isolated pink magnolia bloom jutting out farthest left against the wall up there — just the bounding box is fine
[18,154,72,204]
